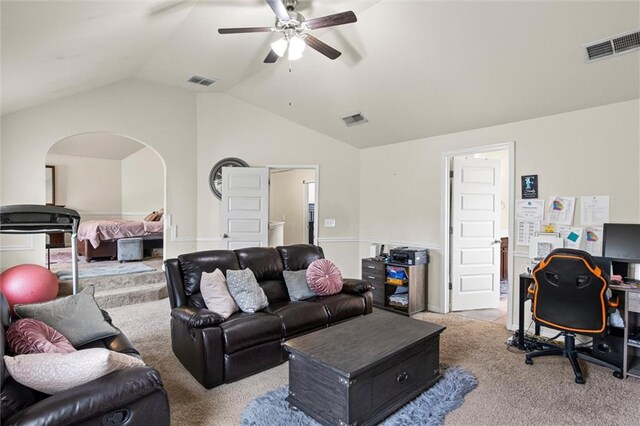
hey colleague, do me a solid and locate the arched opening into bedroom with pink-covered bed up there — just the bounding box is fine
[45,132,166,261]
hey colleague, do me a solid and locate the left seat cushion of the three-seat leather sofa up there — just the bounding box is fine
[220,312,282,354]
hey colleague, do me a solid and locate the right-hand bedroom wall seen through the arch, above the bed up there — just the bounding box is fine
[122,148,164,219]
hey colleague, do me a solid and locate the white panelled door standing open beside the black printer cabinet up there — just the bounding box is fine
[450,157,500,311]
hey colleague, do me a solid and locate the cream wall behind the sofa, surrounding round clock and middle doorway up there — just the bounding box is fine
[197,93,360,277]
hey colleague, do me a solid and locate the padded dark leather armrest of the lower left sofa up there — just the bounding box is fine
[3,367,169,426]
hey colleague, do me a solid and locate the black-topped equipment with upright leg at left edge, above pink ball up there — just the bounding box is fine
[0,204,80,294]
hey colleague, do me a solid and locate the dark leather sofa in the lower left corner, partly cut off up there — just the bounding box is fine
[0,293,170,426]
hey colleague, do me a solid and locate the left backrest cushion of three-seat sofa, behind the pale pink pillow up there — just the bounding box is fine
[178,250,240,302]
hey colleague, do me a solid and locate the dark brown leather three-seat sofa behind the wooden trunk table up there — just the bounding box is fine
[165,244,373,389]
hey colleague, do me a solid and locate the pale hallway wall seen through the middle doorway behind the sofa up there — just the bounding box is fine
[269,169,315,245]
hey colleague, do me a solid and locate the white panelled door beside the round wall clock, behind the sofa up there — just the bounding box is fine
[220,167,269,250]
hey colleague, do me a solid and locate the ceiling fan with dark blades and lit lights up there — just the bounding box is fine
[218,0,358,64]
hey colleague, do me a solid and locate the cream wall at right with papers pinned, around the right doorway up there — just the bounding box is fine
[360,100,640,322]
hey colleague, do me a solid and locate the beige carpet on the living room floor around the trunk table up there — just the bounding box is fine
[109,299,640,426]
